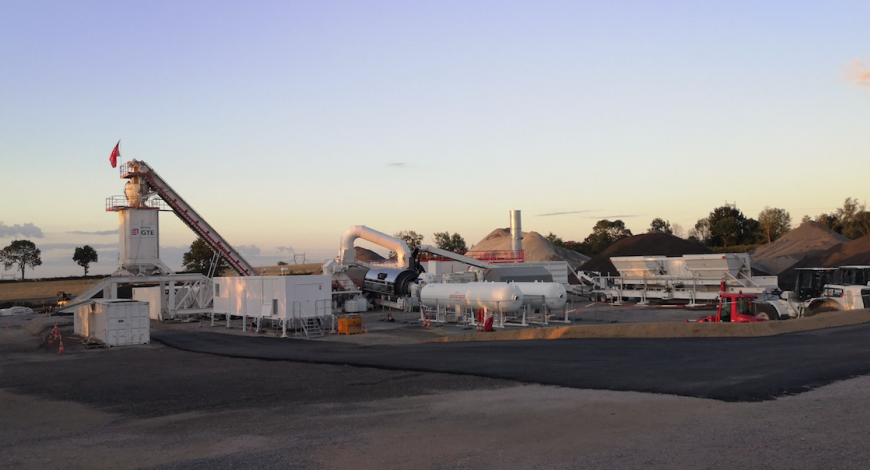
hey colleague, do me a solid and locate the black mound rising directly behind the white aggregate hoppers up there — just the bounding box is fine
[580,232,712,275]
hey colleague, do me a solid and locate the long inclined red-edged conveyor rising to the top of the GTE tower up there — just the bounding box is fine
[121,160,257,276]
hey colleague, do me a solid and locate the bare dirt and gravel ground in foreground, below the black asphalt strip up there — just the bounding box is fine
[0,320,870,469]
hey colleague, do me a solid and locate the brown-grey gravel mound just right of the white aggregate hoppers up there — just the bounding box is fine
[749,222,849,274]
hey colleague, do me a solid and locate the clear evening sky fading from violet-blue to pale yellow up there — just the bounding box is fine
[0,0,870,277]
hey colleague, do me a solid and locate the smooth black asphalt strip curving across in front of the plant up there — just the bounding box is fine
[152,324,870,402]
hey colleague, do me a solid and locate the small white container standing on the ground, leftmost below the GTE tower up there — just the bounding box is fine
[73,299,151,346]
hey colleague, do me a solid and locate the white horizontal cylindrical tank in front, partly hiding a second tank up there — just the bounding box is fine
[420,282,523,312]
